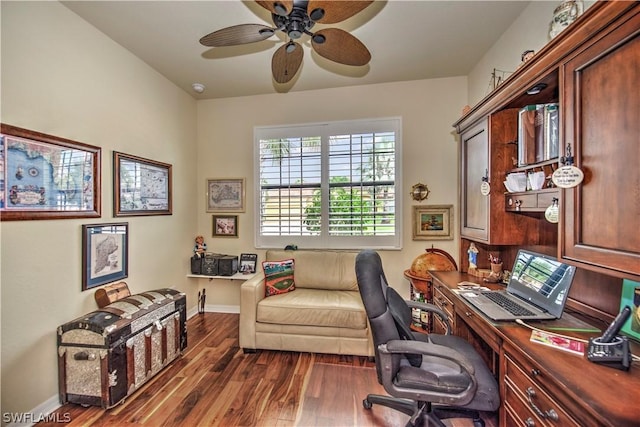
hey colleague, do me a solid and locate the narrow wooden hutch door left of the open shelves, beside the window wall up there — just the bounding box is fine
[460,120,489,240]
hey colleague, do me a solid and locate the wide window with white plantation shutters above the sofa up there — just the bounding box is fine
[255,118,402,249]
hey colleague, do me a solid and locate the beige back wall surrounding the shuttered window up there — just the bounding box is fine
[197,77,467,306]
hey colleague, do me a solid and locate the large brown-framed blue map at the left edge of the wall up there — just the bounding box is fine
[0,123,101,221]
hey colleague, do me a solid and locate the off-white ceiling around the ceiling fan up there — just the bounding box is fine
[63,0,529,99]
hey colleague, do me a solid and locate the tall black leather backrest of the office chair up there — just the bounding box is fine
[356,250,422,379]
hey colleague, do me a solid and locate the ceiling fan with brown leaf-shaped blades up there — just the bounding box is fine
[200,0,373,83]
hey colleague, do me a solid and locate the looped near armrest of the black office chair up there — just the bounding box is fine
[378,340,478,406]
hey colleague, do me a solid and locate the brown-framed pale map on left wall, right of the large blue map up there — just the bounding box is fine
[113,151,172,216]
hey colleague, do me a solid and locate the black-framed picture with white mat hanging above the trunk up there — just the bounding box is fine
[82,222,129,291]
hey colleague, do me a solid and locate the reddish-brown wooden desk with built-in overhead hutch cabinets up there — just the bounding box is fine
[450,1,640,427]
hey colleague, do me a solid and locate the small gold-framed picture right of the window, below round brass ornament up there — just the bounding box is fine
[412,205,453,240]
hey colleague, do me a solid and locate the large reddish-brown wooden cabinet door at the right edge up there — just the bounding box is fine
[560,11,640,280]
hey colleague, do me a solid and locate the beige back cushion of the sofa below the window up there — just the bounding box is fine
[266,250,358,292]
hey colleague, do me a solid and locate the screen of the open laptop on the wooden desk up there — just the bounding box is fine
[507,249,576,317]
